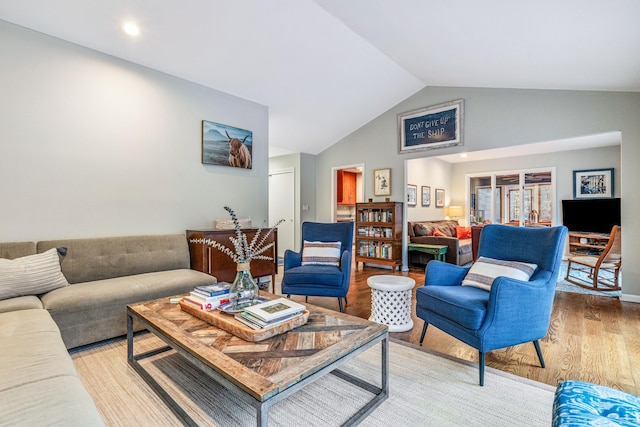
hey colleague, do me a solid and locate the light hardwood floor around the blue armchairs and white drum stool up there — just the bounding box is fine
[276,266,640,395]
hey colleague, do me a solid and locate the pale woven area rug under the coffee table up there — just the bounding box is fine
[72,334,554,427]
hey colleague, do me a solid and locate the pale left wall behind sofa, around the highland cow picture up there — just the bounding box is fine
[0,21,268,241]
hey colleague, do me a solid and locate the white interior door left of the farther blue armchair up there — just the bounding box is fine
[269,170,295,257]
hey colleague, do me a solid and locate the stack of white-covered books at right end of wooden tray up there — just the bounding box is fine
[235,298,306,329]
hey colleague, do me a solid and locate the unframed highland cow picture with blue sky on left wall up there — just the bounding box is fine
[202,120,253,169]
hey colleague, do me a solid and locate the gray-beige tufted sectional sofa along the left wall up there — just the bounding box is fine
[0,234,215,426]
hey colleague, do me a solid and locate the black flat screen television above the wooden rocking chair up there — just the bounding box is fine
[562,198,620,233]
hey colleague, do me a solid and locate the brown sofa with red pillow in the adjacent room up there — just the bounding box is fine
[407,220,473,265]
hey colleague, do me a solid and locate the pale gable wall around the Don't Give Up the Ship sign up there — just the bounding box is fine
[316,87,640,302]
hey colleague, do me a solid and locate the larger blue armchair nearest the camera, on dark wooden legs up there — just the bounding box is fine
[416,224,567,386]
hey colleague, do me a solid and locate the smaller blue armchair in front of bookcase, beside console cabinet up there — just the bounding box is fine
[282,222,353,311]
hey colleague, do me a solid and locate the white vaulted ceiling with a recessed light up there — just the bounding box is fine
[0,0,640,154]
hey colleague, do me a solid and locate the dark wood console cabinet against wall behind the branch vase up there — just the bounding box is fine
[187,228,278,292]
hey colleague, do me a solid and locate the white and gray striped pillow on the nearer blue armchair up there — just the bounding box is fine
[462,257,538,291]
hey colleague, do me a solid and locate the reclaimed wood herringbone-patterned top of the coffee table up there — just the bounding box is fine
[127,292,388,402]
